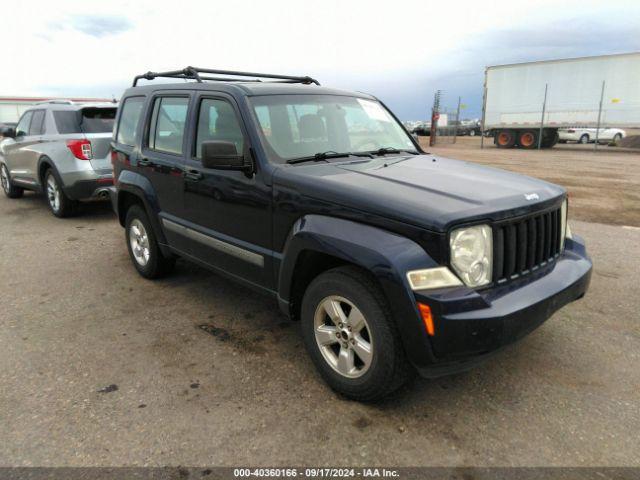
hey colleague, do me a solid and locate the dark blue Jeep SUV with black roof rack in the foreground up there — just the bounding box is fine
[112,67,591,400]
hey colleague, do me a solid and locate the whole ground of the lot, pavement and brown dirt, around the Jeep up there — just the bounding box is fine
[0,142,640,466]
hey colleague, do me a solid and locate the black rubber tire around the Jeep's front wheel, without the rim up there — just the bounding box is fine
[301,266,414,401]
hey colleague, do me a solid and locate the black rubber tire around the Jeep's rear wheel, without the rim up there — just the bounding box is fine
[125,205,176,279]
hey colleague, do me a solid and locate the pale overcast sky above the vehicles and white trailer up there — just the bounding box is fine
[0,0,640,120]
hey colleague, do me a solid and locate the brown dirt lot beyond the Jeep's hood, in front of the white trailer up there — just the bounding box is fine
[420,137,640,226]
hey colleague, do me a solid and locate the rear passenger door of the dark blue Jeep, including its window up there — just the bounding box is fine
[142,93,190,252]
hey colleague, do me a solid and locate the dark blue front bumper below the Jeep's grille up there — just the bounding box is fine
[416,237,592,378]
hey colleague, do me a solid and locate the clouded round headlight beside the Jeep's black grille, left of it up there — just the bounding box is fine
[449,225,493,287]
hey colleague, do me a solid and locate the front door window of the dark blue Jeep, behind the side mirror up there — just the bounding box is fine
[196,98,244,158]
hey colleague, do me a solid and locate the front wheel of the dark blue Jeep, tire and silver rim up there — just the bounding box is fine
[301,267,413,401]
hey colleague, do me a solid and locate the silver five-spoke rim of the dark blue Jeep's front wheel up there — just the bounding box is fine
[314,295,373,378]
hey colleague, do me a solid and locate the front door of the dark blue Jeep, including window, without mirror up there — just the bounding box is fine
[184,95,273,289]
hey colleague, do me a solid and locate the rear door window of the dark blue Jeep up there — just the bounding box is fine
[149,97,189,154]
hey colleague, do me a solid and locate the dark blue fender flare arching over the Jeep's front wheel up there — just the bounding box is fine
[278,215,437,365]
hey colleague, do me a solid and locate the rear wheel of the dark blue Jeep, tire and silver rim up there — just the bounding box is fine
[125,205,176,278]
